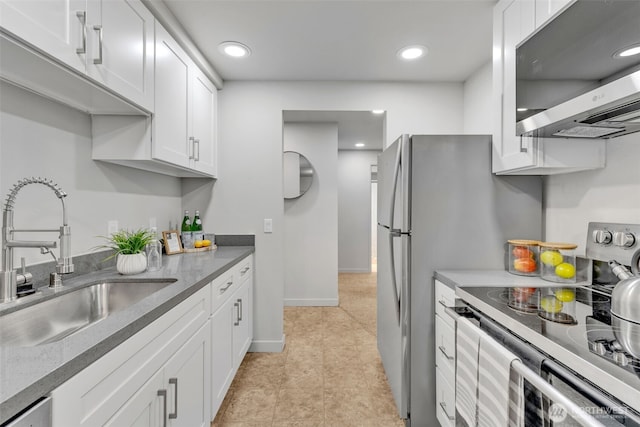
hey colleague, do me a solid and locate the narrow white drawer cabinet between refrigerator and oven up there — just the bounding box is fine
[435,280,456,427]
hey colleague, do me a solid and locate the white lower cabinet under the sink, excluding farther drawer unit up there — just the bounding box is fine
[52,286,211,427]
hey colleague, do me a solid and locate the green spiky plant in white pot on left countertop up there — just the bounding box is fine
[99,229,155,274]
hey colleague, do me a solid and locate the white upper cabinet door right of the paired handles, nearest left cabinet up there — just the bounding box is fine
[86,0,155,111]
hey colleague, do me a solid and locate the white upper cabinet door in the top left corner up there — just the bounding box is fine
[0,0,87,73]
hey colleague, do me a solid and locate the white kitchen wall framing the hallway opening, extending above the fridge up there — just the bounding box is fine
[188,81,463,351]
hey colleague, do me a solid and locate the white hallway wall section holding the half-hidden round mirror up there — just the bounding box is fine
[283,123,338,306]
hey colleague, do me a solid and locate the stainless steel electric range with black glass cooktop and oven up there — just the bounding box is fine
[448,223,640,427]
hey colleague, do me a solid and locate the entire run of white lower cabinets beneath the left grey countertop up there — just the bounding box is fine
[51,255,253,427]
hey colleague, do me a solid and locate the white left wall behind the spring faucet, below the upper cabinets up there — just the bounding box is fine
[0,83,181,264]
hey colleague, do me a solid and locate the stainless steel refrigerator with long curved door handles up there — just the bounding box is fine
[377,135,542,427]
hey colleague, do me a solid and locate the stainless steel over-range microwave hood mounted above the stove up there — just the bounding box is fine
[516,0,640,138]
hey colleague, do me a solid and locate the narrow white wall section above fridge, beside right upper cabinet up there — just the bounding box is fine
[464,61,494,135]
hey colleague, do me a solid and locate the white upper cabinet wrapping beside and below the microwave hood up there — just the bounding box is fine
[492,0,605,175]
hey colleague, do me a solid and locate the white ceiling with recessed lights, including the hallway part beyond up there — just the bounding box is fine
[164,0,496,149]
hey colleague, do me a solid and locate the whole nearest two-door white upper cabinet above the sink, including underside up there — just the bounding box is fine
[0,0,155,115]
